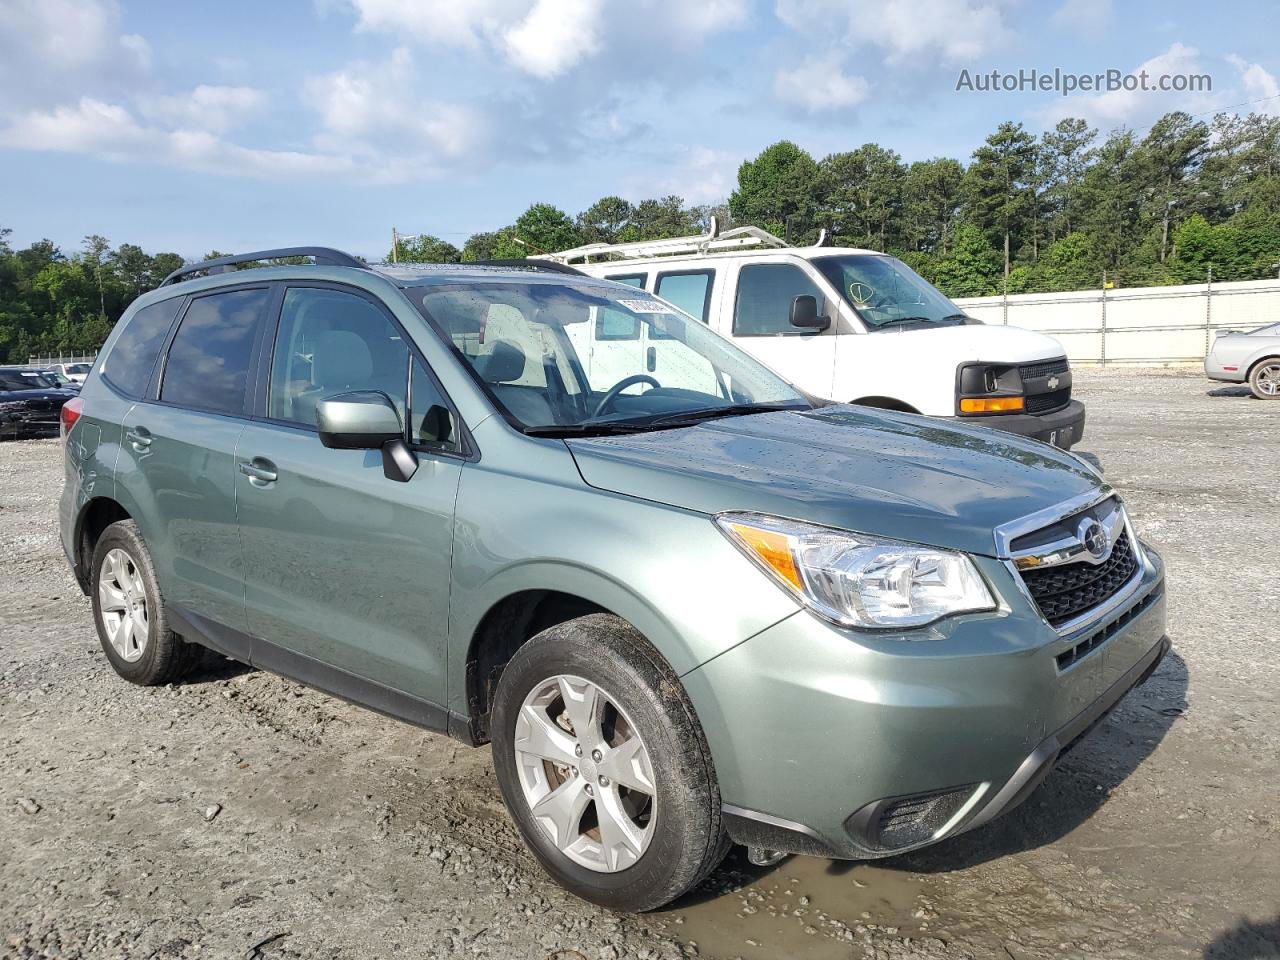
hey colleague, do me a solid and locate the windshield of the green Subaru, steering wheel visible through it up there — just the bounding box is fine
[406,280,809,433]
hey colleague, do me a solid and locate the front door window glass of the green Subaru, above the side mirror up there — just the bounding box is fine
[266,287,408,426]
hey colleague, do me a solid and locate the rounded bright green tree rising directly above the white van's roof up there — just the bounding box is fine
[728,140,818,241]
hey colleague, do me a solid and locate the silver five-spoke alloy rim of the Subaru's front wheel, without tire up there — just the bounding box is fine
[515,675,655,873]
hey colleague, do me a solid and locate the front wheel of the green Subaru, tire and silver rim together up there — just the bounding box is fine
[492,613,728,911]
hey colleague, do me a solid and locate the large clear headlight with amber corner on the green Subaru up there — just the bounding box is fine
[716,513,996,627]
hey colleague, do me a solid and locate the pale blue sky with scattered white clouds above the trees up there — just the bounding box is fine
[0,0,1280,256]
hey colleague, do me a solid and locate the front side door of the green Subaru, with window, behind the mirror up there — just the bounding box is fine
[236,284,465,711]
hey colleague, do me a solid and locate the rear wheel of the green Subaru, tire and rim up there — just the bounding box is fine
[90,520,204,686]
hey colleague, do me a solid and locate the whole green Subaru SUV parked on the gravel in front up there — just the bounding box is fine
[60,247,1169,910]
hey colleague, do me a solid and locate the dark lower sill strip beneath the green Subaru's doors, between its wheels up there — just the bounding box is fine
[166,607,475,746]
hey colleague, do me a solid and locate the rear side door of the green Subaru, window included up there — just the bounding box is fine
[115,284,273,647]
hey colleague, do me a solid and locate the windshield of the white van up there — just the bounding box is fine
[813,253,968,332]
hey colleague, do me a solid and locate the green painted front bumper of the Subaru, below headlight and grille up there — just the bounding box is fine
[684,548,1169,859]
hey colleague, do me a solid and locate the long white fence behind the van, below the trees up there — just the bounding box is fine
[955,280,1280,366]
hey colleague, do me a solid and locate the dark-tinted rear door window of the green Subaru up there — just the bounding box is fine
[160,288,270,415]
